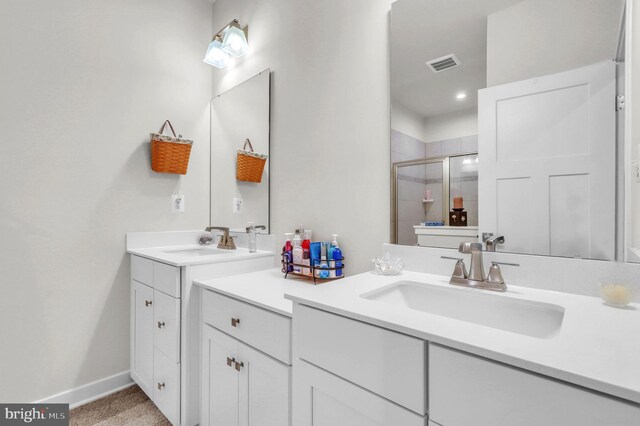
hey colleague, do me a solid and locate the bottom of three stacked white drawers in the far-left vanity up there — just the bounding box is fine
[153,348,180,425]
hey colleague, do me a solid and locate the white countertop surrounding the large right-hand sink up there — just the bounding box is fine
[284,272,640,403]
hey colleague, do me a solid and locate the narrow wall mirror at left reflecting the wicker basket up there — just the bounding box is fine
[210,70,270,232]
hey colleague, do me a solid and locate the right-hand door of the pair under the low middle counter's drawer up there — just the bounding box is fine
[238,343,291,426]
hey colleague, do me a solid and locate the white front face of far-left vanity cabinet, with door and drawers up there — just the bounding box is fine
[131,256,180,425]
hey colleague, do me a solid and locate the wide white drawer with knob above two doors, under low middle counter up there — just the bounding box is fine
[202,290,291,364]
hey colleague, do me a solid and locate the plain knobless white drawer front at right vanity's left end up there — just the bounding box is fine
[294,305,427,415]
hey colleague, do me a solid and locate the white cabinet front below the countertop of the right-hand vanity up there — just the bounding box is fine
[293,303,640,426]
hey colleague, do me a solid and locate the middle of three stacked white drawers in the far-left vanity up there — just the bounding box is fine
[153,290,180,362]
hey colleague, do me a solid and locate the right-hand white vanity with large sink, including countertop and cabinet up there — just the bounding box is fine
[286,272,640,426]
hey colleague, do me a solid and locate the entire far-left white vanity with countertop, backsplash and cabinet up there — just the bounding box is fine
[127,231,274,425]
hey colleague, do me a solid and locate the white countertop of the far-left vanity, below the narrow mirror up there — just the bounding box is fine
[127,244,273,266]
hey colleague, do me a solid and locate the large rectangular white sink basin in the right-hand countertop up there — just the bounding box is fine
[361,281,564,338]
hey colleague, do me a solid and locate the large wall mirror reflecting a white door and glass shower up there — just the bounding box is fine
[390,0,632,260]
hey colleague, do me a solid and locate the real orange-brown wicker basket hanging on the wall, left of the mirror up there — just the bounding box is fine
[151,120,193,175]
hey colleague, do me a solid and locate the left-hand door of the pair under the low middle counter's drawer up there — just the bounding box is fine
[200,325,239,426]
